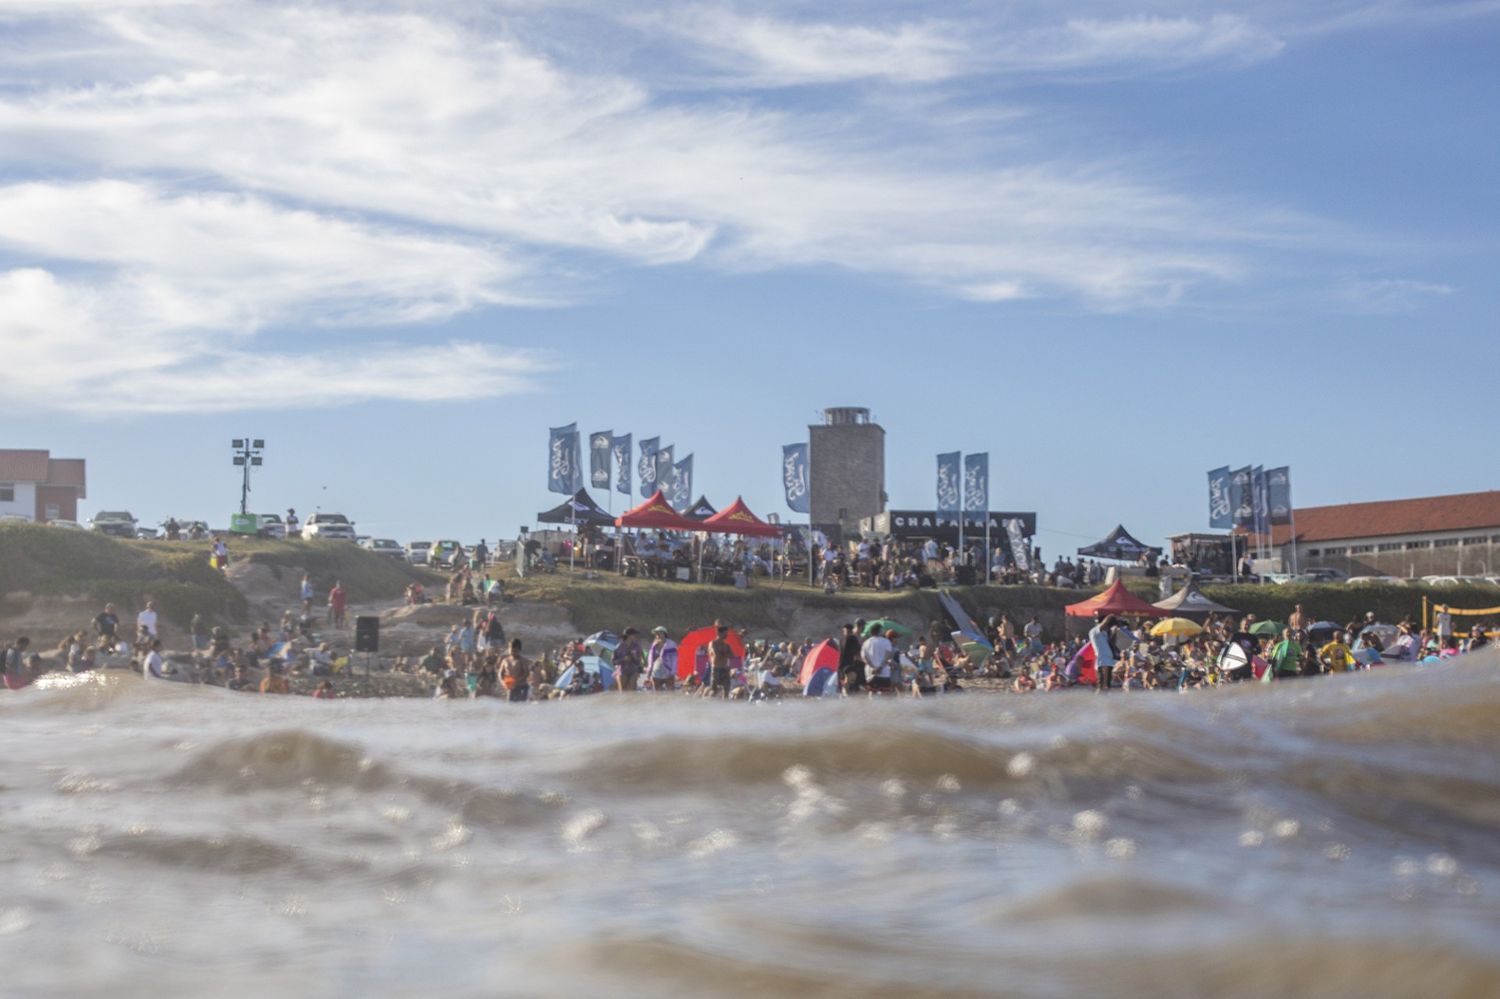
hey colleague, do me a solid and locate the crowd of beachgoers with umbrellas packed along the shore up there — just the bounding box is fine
[3,573,1491,701]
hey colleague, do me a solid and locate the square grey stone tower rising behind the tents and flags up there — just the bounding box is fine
[807,407,885,531]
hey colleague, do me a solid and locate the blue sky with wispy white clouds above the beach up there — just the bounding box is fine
[0,0,1500,560]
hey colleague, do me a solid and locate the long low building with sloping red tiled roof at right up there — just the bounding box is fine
[1272,491,1500,576]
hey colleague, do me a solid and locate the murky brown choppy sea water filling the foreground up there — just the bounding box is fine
[0,657,1500,999]
